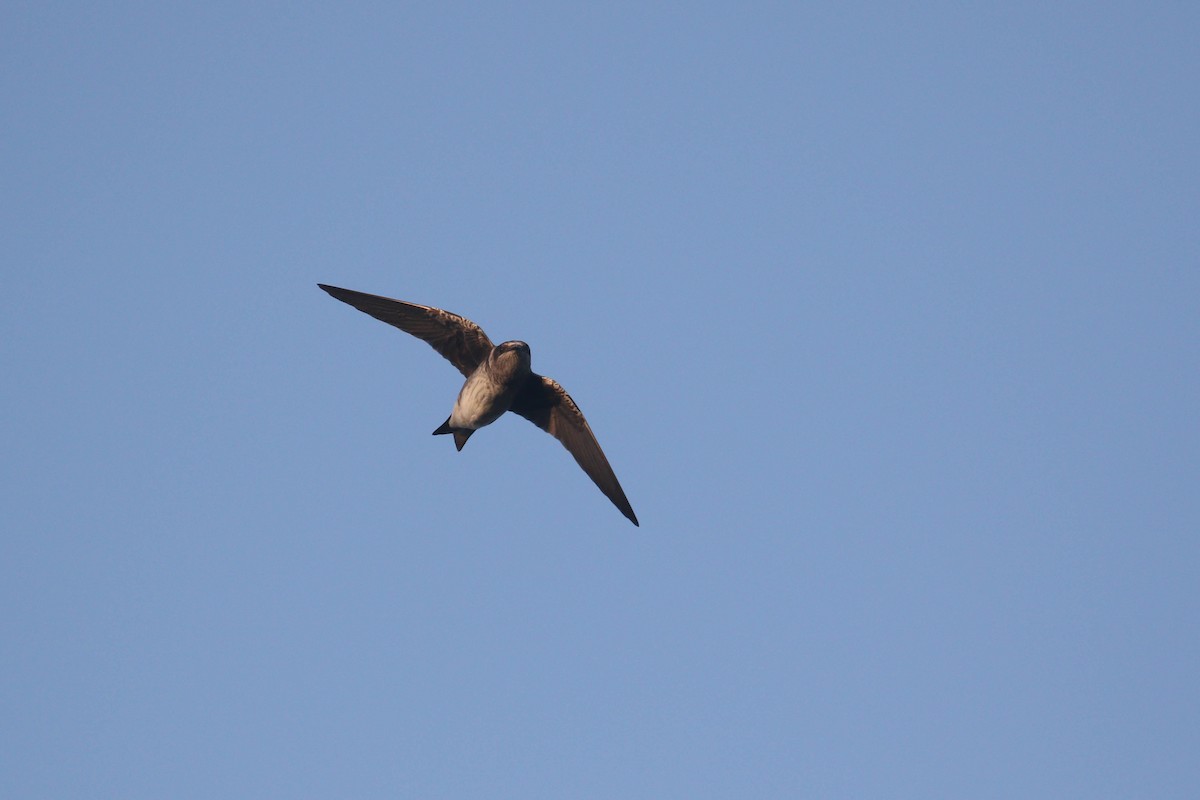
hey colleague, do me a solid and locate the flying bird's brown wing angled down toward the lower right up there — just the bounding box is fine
[509,373,637,525]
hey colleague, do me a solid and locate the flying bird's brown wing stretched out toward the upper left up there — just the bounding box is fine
[317,283,492,375]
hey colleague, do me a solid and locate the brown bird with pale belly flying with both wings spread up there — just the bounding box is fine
[317,283,641,527]
